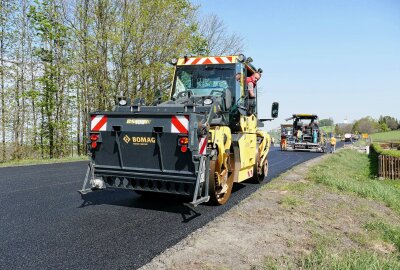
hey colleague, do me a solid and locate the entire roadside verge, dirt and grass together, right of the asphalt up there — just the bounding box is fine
[144,149,400,270]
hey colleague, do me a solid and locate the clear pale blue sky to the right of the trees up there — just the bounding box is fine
[192,0,400,128]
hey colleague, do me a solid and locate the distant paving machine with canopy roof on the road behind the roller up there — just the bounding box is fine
[282,114,326,152]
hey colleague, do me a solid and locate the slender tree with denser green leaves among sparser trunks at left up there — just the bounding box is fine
[29,0,67,158]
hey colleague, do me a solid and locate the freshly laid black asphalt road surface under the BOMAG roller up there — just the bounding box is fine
[0,148,342,269]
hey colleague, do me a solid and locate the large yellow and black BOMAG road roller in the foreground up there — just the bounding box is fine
[79,54,279,206]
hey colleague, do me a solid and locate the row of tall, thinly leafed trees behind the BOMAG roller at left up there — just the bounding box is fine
[0,0,244,162]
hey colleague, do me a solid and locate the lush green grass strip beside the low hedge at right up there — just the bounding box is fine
[308,150,400,213]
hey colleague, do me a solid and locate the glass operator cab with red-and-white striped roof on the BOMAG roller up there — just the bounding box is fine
[166,54,278,129]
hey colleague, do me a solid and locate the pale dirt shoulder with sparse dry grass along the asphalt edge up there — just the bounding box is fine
[141,155,400,270]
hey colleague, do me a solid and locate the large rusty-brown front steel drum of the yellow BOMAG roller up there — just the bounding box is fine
[208,158,233,205]
